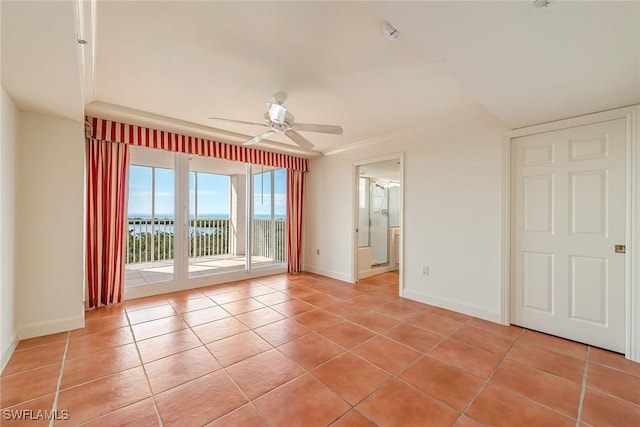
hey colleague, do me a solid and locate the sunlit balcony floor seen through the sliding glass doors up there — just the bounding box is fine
[124,255,278,287]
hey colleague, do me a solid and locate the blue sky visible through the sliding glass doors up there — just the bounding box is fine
[128,165,286,217]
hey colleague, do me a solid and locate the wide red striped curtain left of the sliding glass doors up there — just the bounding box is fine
[86,138,129,308]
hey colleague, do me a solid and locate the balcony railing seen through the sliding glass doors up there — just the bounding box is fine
[125,218,286,264]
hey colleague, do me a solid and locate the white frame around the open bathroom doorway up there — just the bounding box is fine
[351,152,404,297]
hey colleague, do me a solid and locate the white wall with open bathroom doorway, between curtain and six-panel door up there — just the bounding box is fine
[304,117,507,321]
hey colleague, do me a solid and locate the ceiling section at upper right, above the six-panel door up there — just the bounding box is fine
[372,0,640,128]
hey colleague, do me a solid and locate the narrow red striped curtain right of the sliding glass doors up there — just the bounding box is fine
[287,169,304,273]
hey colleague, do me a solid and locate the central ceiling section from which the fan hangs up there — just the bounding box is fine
[87,2,481,155]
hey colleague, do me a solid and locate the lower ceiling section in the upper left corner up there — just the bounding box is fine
[0,0,84,120]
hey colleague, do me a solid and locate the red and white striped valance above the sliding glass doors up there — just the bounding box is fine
[87,116,309,172]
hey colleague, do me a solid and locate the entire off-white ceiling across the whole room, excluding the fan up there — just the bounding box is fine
[0,1,640,155]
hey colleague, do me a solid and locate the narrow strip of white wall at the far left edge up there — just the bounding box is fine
[0,89,20,371]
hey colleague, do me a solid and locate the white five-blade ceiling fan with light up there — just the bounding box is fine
[209,93,342,148]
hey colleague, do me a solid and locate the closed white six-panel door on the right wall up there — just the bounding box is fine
[511,119,626,352]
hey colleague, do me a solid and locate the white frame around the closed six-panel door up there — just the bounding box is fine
[500,105,640,362]
